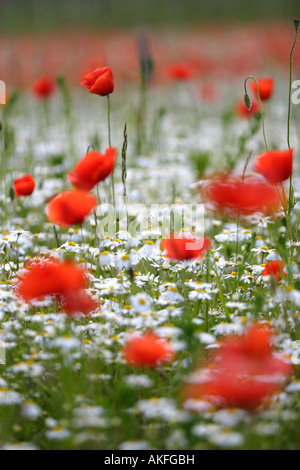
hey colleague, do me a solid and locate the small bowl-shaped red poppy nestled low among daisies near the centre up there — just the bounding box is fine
[162,235,211,261]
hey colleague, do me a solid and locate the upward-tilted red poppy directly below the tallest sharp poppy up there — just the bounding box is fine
[68,147,117,191]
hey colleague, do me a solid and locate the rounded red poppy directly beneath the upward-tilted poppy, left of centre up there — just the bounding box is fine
[46,190,97,227]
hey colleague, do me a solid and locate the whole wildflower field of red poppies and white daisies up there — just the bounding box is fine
[0,5,300,451]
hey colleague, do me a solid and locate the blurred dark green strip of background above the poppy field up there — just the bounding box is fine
[0,0,300,34]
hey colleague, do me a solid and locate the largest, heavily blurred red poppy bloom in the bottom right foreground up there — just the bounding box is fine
[184,324,293,410]
